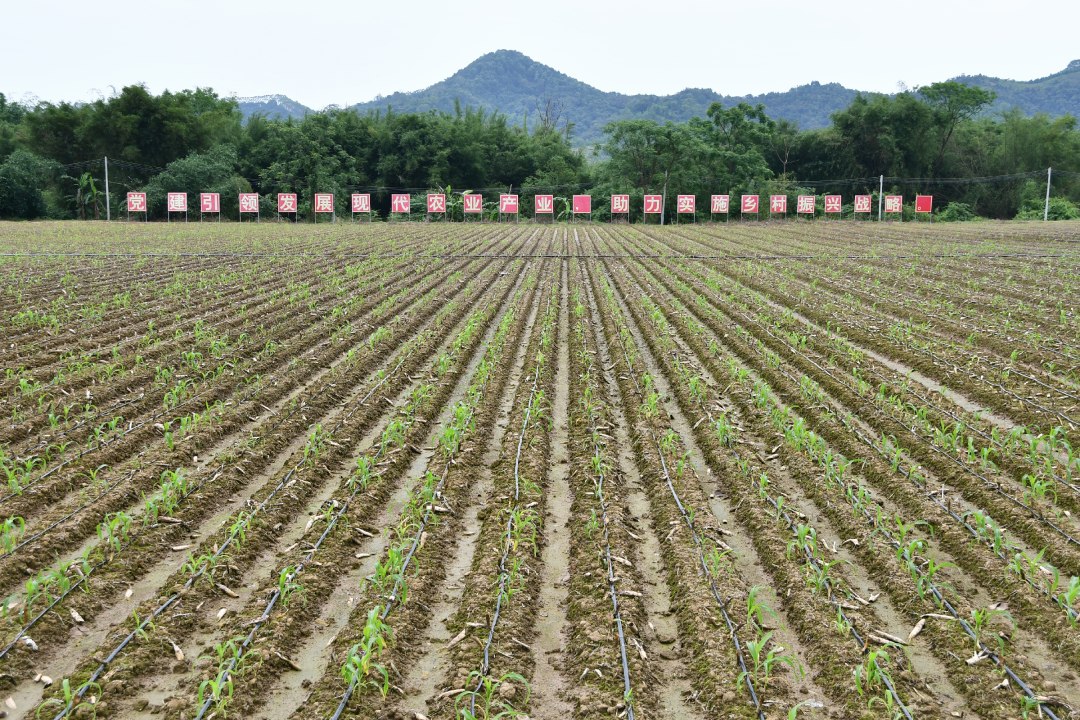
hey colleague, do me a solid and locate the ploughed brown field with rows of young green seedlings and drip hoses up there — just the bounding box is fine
[0,221,1080,720]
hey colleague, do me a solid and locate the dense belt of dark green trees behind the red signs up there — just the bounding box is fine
[0,77,1080,220]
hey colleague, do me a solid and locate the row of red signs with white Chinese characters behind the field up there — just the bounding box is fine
[127,192,933,215]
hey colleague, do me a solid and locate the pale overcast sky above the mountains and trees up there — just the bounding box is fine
[0,0,1080,109]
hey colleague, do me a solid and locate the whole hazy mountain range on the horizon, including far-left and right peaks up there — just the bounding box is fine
[238,50,1080,145]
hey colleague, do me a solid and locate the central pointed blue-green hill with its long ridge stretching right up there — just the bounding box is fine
[353,50,855,145]
